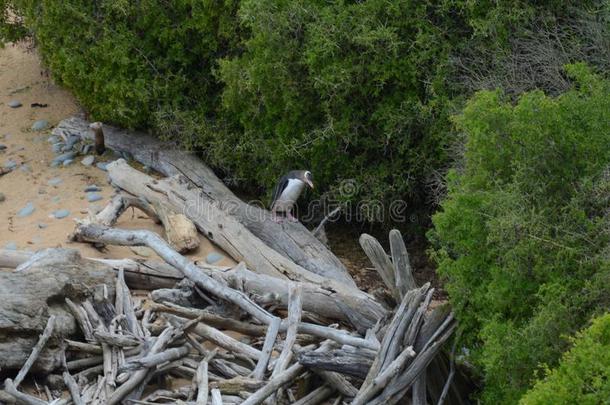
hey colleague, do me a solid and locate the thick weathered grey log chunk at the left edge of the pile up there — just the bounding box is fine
[0,249,115,372]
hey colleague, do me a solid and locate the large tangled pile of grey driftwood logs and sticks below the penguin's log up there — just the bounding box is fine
[0,118,459,405]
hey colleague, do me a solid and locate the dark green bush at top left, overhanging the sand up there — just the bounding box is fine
[0,0,241,128]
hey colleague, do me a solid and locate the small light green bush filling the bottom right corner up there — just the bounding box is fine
[520,314,610,405]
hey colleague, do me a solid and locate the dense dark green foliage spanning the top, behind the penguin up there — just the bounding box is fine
[0,0,607,219]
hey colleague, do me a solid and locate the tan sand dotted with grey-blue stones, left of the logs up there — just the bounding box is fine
[0,44,234,265]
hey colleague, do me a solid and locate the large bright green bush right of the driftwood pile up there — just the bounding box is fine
[430,65,610,404]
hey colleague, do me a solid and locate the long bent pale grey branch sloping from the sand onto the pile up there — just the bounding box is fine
[74,224,271,323]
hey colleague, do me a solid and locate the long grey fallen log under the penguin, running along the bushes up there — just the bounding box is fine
[53,117,355,286]
